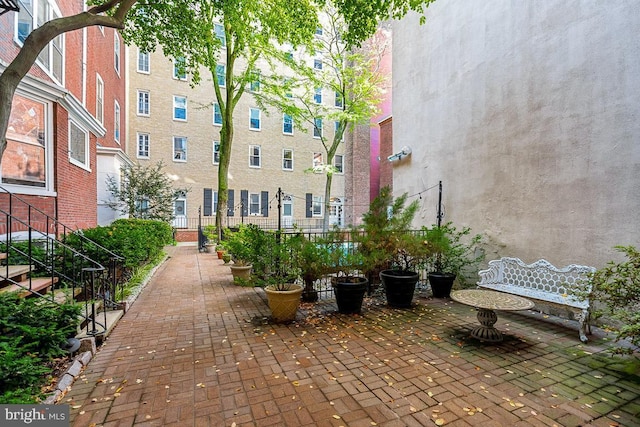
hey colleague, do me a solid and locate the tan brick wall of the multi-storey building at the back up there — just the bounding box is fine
[127,47,345,226]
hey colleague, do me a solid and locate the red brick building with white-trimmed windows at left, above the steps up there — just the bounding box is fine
[0,0,127,234]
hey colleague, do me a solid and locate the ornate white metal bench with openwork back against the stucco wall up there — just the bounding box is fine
[477,257,596,342]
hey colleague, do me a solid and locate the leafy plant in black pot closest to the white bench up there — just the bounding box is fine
[423,222,484,298]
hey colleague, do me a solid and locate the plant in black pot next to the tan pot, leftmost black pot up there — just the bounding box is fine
[325,228,369,314]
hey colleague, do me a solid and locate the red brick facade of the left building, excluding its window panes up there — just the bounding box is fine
[0,0,126,234]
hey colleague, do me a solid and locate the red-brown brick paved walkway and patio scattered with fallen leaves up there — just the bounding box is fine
[61,246,640,427]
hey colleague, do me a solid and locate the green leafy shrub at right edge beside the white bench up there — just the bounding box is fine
[575,246,640,353]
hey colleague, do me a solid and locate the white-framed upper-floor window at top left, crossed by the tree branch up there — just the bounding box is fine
[15,0,64,84]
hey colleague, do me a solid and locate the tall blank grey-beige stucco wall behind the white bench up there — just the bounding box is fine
[393,0,640,266]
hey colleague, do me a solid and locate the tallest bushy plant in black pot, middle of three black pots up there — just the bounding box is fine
[360,187,431,307]
